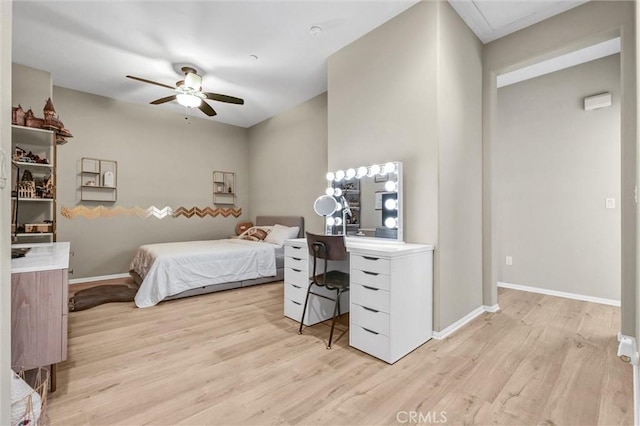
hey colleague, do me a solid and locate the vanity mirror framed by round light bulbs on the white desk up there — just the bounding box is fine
[325,162,403,241]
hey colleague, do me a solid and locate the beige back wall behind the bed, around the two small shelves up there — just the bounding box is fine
[53,87,249,279]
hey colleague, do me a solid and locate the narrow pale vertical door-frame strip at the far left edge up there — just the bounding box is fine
[0,1,12,425]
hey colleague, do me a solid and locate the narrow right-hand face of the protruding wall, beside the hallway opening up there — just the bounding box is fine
[434,2,482,330]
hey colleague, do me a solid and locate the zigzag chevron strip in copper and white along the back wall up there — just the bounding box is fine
[60,206,242,219]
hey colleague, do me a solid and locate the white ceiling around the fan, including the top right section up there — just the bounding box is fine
[12,0,584,127]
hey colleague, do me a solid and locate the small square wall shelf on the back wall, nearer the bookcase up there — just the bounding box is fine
[80,157,118,202]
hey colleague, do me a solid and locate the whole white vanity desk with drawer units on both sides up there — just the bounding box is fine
[284,238,433,364]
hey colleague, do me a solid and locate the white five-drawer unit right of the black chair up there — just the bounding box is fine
[348,244,433,364]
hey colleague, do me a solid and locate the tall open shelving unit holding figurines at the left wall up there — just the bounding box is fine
[11,125,56,243]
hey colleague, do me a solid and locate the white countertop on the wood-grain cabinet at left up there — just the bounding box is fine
[11,242,71,274]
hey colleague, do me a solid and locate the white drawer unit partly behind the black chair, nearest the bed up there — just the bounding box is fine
[284,238,349,325]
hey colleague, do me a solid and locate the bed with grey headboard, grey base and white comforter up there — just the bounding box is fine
[130,216,304,308]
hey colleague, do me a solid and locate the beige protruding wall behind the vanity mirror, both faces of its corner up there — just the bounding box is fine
[328,2,482,330]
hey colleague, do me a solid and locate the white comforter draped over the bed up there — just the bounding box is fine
[130,239,278,308]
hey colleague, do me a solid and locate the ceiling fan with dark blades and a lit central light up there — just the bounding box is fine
[127,67,244,117]
